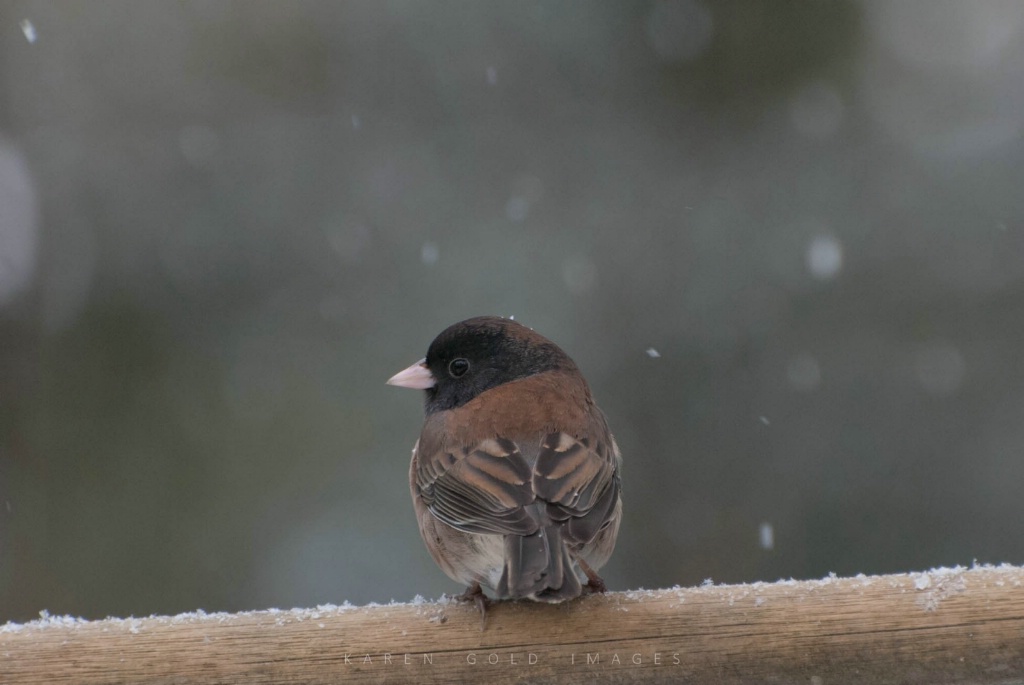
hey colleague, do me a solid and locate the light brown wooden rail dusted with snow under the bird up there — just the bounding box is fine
[0,566,1024,685]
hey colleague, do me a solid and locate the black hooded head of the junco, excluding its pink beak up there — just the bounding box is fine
[424,316,575,414]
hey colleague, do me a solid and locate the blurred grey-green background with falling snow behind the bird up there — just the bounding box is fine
[0,0,1024,620]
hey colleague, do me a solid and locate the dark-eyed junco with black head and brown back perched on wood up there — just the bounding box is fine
[388,316,622,610]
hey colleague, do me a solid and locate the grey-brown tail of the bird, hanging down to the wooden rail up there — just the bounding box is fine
[497,525,583,603]
